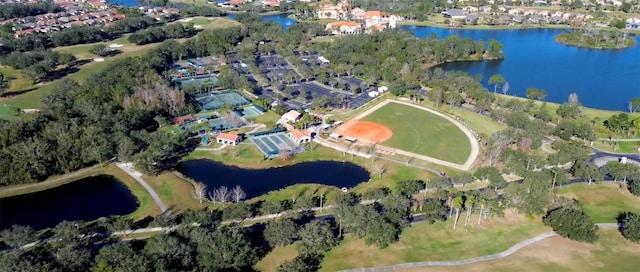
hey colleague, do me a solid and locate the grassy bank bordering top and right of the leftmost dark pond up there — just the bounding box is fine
[0,164,160,220]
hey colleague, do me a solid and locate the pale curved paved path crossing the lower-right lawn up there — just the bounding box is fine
[341,223,618,272]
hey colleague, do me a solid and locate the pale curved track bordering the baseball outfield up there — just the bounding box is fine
[342,99,480,170]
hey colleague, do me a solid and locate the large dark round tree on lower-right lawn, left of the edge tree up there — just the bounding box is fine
[542,207,598,243]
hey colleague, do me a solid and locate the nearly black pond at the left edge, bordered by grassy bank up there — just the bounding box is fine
[0,176,139,229]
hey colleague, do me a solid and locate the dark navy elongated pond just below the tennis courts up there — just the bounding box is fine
[178,159,370,199]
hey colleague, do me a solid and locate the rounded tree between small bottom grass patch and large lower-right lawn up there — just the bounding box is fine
[298,220,339,255]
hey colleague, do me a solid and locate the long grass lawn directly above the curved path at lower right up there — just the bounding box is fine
[321,212,549,271]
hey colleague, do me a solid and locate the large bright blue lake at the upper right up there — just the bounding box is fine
[399,26,640,110]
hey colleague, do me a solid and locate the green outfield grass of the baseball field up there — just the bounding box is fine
[362,103,471,164]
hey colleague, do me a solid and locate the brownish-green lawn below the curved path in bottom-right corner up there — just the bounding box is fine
[398,229,640,272]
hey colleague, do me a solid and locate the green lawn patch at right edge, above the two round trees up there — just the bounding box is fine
[558,182,640,223]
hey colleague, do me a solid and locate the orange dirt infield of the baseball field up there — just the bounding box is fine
[333,119,393,145]
